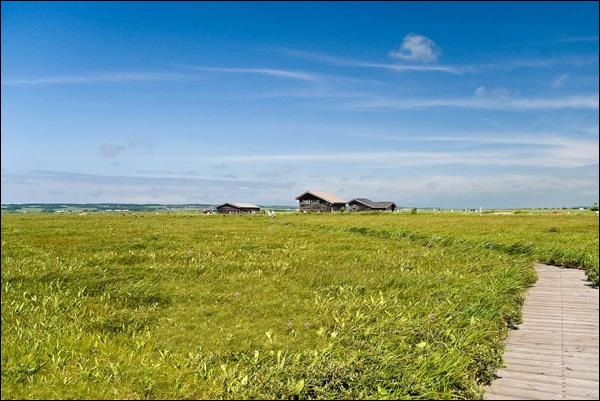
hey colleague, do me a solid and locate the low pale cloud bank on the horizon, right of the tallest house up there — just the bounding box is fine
[302,171,598,209]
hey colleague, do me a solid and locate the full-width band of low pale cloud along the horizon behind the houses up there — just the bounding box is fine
[1,165,598,208]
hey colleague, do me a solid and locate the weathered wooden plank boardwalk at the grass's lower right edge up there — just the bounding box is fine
[485,264,598,400]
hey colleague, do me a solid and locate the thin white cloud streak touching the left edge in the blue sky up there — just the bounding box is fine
[2,72,192,86]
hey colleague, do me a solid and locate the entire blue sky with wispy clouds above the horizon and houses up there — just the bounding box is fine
[1,2,599,208]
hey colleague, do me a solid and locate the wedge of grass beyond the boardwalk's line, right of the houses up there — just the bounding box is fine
[286,212,598,286]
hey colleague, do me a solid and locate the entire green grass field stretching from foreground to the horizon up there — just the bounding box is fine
[2,213,598,399]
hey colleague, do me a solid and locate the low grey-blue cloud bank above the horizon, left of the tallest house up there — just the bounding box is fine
[2,170,291,204]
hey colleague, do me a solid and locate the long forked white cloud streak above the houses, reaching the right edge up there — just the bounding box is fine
[195,133,598,168]
